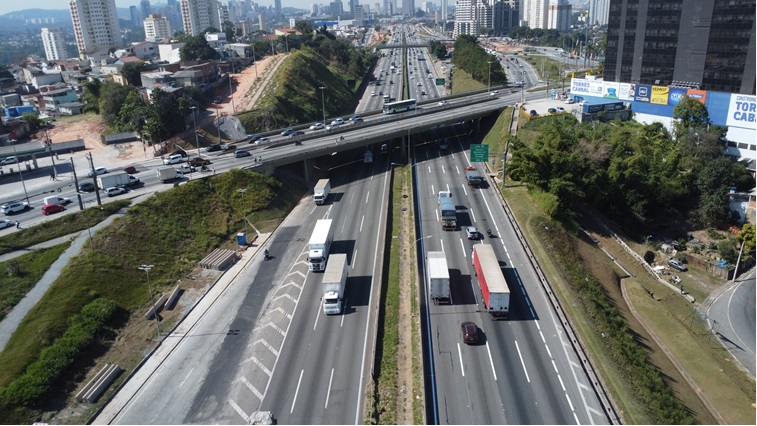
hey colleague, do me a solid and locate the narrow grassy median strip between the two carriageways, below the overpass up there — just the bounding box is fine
[365,166,424,424]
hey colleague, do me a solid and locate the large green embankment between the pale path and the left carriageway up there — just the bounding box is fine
[0,170,305,421]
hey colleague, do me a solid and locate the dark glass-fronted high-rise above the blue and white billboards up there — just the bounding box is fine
[604,0,755,95]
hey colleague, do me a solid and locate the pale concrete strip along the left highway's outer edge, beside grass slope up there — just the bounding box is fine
[90,233,271,424]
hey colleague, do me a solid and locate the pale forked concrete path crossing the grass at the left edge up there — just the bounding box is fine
[0,214,122,351]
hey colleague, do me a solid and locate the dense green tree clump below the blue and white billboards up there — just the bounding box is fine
[508,100,754,230]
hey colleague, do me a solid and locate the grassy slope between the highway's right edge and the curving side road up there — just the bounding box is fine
[505,118,755,424]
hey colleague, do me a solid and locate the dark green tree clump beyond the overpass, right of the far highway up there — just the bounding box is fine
[452,35,507,86]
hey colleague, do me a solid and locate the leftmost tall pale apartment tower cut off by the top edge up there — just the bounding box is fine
[68,0,121,56]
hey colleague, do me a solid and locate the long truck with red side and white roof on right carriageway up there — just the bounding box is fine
[473,244,510,319]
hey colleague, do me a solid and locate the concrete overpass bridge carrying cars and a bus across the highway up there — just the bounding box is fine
[243,94,510,179]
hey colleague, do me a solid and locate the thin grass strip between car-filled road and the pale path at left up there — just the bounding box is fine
[0,200,130,254]
